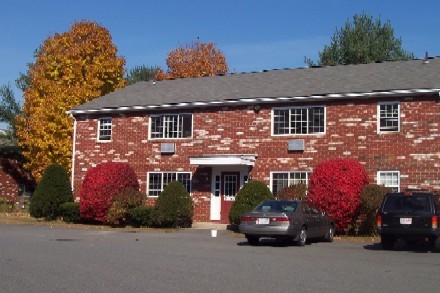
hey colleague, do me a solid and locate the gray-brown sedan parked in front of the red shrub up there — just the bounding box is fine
[239,200,335,246]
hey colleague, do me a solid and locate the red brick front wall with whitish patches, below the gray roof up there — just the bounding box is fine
[74,96,440,221]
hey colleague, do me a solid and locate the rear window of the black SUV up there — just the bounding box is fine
[383,196,431,212]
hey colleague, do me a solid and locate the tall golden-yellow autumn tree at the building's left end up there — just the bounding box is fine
[16,21,125,181]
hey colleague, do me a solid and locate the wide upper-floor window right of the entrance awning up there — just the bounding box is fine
[273,106,325,135]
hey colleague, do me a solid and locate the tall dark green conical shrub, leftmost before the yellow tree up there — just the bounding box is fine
[29,164,73,221]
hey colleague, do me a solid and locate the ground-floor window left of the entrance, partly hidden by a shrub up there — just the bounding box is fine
[147,172,191,196]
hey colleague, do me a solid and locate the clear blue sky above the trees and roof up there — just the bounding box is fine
[0,0,440,100]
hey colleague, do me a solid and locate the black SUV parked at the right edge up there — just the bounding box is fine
[377,192,440,250]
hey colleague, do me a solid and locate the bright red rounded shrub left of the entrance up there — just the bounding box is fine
[80,162,139,222]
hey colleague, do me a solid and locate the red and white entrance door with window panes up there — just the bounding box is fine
[221,172,240,222]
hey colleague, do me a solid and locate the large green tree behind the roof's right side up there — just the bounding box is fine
[305,14,414,66]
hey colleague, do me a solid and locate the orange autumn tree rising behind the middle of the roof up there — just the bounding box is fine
[156,39,228,80]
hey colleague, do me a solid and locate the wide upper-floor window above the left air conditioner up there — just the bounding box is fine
[150,114,192,138]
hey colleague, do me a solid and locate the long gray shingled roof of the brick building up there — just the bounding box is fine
[68,57,440,114]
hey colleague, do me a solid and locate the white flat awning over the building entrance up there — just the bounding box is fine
[189,154,257,166]
